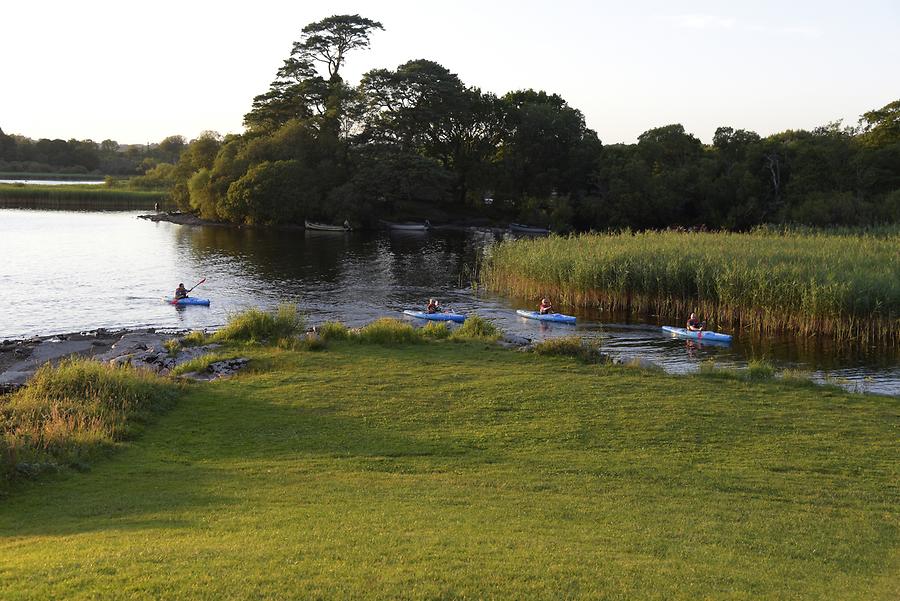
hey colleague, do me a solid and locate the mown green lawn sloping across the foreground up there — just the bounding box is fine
[0,342,900,600]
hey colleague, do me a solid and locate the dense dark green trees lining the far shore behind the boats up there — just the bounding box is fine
[158,15,900,231]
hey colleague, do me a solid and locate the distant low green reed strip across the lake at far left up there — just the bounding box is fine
[0,184,168,209]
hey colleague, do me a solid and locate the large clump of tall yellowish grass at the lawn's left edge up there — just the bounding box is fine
[0,358,178,486]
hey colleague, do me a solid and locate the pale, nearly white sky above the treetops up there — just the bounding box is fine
[0,0,900,144]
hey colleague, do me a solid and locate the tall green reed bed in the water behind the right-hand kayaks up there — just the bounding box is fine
[482,228,900,347]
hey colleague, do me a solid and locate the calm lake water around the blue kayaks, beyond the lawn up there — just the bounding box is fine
[0,209,900,395]
